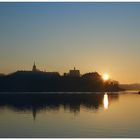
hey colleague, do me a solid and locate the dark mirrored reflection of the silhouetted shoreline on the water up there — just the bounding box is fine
[0,93,119,119]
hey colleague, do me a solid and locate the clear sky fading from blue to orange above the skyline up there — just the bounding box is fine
[0,2,140,83]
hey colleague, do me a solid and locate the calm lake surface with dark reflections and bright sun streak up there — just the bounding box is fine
[0,92,140,138]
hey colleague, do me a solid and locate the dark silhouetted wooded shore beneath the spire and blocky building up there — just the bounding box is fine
[0,71,122,92]
